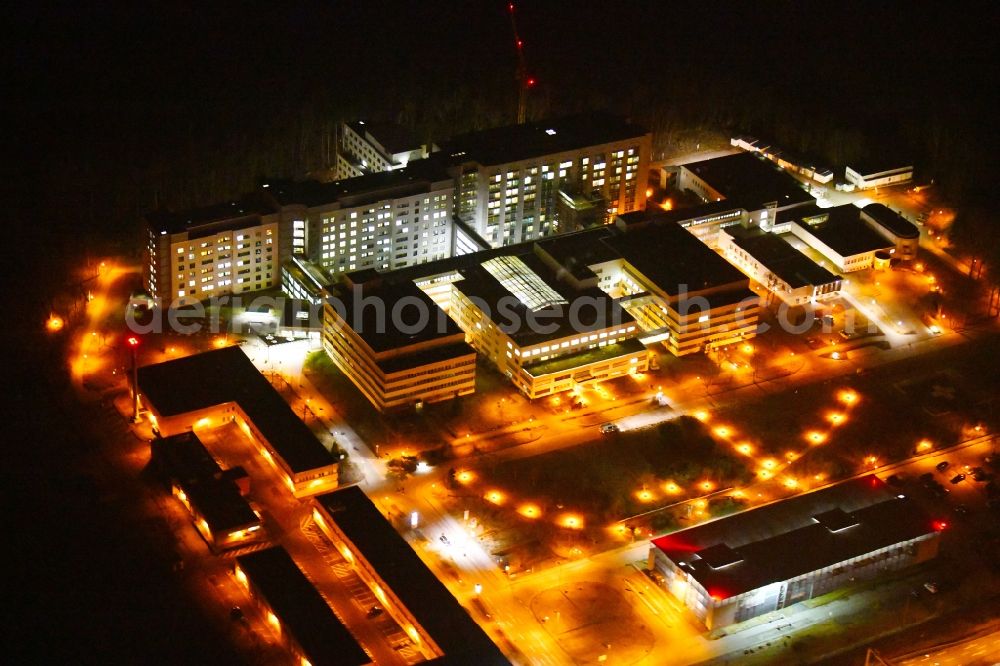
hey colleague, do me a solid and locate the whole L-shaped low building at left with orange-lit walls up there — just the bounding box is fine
[138,346,338,497]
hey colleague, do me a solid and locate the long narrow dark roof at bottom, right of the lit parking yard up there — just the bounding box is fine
[315,486,510,666]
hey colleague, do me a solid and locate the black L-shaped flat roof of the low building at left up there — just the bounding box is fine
[138,346,336,474]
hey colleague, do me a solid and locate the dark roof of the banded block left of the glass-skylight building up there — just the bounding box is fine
[328,276,462,354]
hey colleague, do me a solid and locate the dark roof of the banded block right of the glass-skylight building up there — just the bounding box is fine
[605,222,749,296]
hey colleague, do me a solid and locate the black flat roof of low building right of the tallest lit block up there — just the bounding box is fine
[682,152,816,210]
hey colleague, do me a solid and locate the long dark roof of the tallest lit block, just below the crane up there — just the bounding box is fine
[441,112,647,165]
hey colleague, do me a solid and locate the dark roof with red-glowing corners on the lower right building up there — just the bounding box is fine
[652,475,934,599]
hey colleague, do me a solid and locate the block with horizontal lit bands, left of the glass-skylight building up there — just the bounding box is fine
[323,271,476,411]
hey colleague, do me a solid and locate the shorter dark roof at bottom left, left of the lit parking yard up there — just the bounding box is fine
[236,547,372,666]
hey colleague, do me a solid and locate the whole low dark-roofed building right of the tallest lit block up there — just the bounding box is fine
[677,153,816,231]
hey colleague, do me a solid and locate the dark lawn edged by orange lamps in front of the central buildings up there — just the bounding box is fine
[480,417,749,524]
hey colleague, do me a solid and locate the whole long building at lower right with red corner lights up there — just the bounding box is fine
[649,475,940,629]
